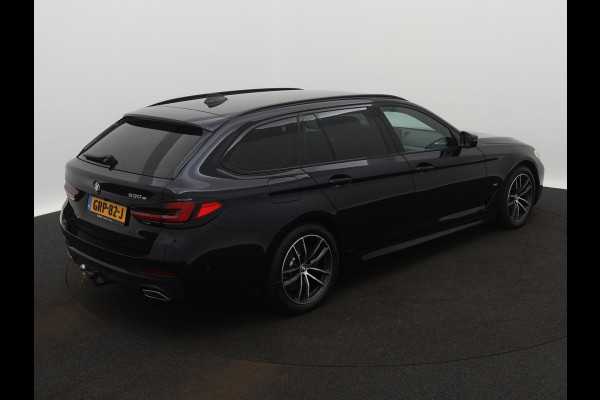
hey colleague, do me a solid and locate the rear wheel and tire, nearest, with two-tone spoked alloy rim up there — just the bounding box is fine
[263,224,340,314]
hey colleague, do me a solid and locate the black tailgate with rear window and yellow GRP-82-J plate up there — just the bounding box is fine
[65,118,208,253]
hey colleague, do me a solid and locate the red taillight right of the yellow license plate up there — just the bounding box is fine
[131,201,223,223]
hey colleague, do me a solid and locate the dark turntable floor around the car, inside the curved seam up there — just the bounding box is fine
[65,203,566,365]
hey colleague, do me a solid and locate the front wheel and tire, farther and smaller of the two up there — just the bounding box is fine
[498,166,537,229]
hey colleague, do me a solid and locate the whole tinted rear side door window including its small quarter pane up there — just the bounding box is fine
[303,107,389,164]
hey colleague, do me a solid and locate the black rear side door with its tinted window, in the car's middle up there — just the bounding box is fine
[300,107,413,251]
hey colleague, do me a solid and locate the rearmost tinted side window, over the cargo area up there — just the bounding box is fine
[224,118,298,172]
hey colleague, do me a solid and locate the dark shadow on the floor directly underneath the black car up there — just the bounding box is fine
[65,219,502,332]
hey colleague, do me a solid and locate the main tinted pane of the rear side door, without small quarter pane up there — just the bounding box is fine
[317,108,388,160]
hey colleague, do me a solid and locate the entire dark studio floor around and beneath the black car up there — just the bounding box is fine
[34,188,567,400]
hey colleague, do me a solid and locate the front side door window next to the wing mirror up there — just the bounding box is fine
[381,107,457,152]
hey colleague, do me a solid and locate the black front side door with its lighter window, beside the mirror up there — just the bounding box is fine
[380,105,492,233]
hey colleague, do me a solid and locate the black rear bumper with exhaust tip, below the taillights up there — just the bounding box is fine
[60,202,273,300]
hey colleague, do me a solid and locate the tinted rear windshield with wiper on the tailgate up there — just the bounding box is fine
[79,118,202,178]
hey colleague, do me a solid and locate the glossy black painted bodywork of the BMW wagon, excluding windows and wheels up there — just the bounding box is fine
[60,90,544,299]
